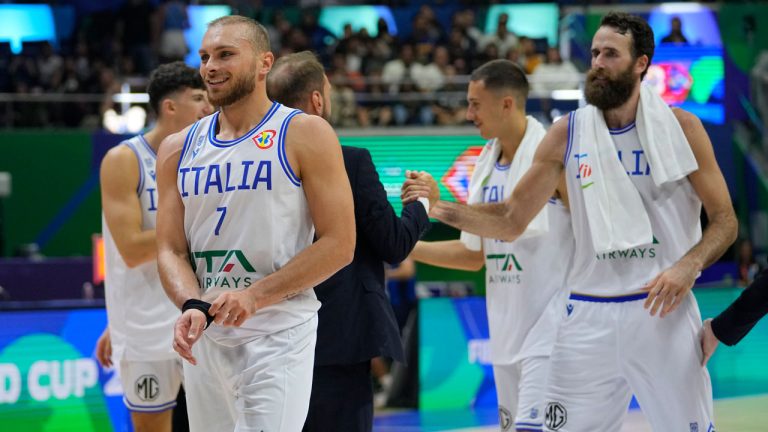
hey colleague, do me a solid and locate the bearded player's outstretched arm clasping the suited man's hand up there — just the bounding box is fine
[430,117,568,241]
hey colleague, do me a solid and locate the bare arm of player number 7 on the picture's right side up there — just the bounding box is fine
[238,115,355,308]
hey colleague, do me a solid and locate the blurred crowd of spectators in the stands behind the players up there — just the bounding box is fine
[0,0,582,128]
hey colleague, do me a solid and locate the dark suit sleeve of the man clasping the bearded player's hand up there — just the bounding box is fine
[355,149,430,264]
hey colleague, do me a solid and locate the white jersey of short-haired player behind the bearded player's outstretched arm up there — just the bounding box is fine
[483,160,574,364]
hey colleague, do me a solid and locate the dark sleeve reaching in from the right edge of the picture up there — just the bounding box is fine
[712,269,768,345]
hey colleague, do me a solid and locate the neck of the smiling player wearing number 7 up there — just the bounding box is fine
[216,87,272,140]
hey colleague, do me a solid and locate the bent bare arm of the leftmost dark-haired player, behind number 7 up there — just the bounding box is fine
[100,145,157,267]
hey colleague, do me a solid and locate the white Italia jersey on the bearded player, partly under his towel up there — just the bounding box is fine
[564,111,701,296]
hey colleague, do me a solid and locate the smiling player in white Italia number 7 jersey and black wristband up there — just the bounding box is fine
[157,16,355,432]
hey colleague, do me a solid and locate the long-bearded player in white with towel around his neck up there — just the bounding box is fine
[408,13,737,432]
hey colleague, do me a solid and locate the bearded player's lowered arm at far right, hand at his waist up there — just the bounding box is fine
[645,109,738,317]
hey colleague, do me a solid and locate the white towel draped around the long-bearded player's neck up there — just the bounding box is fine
[574,85,698,253]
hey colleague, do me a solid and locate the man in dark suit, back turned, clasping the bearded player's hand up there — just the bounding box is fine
[267,51,439,432]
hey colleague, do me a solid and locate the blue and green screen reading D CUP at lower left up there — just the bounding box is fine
[0,309,131,432]
